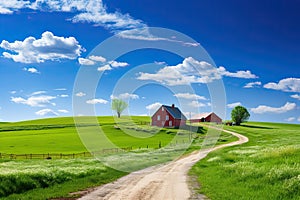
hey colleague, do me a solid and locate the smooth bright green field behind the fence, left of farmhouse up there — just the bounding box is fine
[0,117,192,154]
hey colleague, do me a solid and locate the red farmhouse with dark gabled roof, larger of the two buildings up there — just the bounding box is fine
[151,104,186,127]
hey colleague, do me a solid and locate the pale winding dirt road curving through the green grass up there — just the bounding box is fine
[80,127,248,200]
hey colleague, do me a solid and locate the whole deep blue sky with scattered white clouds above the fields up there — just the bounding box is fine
[0,0,300,123]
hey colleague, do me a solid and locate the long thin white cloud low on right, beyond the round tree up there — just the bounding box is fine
[251,102,296,114]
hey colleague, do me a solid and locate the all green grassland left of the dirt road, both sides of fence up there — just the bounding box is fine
[0,117,236,199]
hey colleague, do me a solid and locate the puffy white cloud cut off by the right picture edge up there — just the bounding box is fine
[264,78,300,92]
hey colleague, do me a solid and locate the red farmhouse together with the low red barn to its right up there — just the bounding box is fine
[151,104,222,127]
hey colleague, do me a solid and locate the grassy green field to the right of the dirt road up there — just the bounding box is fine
[190,122,300,200]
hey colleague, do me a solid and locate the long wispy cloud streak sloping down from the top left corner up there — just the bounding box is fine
[0,0,199,44]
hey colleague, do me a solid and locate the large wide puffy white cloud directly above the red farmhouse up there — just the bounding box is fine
[137,57,257,86]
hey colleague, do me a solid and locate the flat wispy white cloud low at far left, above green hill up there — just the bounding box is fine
[11,95,56,107]
